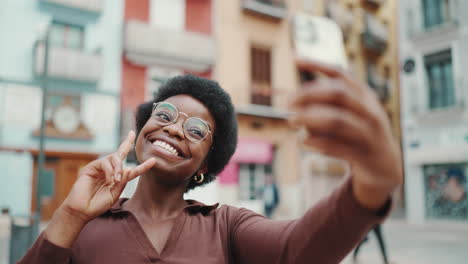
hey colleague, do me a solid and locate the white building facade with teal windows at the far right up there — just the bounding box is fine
[399,0,468,223]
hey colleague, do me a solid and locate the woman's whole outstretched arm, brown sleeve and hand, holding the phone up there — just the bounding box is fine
[233,61,403,264]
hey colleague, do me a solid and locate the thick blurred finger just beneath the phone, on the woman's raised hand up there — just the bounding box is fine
[291,81,375,120]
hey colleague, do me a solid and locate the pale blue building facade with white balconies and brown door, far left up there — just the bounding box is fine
[0,0,123,220]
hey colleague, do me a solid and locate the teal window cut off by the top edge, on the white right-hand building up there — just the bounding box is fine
[423,0,451,28]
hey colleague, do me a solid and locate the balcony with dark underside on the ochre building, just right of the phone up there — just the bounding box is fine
[361,13,389,55]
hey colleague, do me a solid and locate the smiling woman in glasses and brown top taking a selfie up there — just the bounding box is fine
[20,60,402,264]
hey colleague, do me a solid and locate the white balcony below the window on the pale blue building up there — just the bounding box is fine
[34,44,102,83]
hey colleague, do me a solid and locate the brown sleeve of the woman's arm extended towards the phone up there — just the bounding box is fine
[232,175,390,264]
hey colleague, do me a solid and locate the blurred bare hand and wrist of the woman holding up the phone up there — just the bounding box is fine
[290,61,403,209]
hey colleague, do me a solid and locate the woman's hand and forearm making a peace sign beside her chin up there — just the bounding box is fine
[18,131,155,264]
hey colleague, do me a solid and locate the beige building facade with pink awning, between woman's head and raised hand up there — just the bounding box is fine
[214,0,322,219]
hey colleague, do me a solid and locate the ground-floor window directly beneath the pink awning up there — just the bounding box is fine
[239,164,272,200]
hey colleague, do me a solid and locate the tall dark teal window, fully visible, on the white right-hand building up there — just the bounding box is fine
[424,50,455,109]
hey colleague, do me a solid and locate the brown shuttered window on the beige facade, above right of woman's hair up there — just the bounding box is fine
[250,47,271,105]
